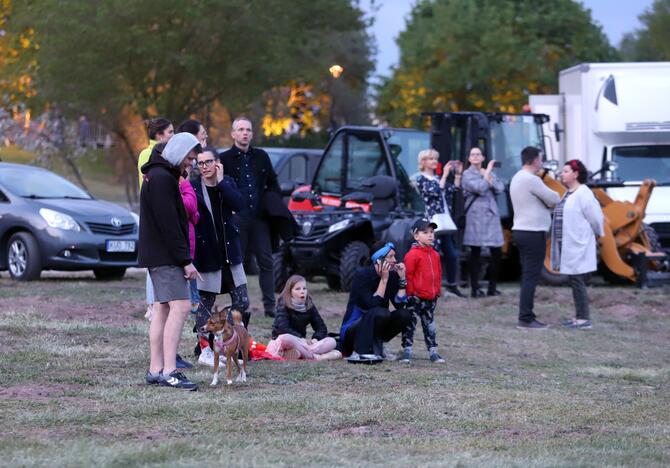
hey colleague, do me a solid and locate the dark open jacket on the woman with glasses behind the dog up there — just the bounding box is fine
[191,175,242,273]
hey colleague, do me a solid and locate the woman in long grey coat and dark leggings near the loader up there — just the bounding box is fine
[461,146,505,298]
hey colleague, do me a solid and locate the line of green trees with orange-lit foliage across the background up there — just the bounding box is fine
[0,0,670,203]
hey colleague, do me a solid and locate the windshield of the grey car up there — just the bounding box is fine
[0,168,91,200]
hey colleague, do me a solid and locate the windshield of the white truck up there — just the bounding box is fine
[612,145,670,184]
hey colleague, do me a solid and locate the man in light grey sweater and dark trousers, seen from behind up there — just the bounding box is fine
[510,146,561,329]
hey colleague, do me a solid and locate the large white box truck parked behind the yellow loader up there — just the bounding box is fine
[529,62,670,249]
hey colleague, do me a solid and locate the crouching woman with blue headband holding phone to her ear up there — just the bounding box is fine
[338,241,412,362]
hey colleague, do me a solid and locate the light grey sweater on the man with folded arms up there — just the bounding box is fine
[509,169,561,232]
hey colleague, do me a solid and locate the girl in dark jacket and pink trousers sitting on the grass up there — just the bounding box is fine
[266,275,342,361]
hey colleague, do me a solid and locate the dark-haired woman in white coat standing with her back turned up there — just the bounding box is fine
[551,159,604,330]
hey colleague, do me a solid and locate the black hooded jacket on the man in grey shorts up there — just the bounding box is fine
[138,150,191,267]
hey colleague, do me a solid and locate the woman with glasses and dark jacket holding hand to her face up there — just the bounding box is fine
[191,147,250,366]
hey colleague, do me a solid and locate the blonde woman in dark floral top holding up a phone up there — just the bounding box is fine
[415,149,465,297]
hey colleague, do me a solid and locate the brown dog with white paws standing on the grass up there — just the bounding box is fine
[202,307,249,387]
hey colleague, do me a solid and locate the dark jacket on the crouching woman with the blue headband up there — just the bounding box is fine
[342,265,404,330]
